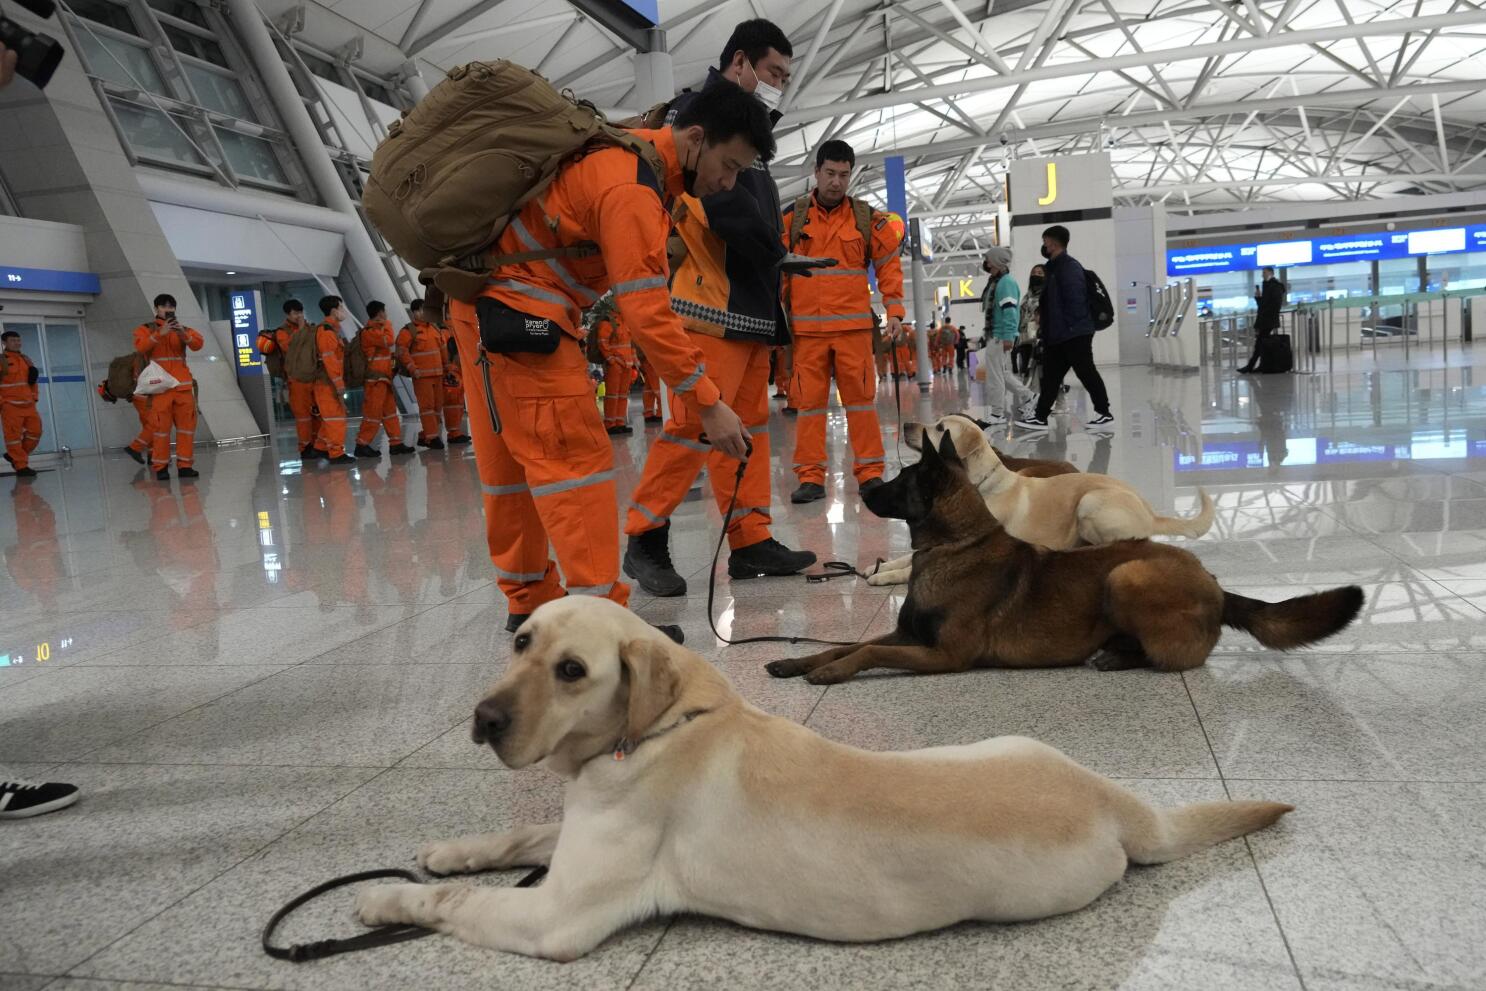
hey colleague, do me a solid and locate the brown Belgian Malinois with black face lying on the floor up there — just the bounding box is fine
[767,434,1363,685]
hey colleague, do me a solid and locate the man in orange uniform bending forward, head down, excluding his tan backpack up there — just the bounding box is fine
[449,88,774,630]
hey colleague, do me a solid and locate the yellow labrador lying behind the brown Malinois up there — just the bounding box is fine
[866,413,1216,585]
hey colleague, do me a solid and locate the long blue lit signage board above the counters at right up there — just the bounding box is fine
[1167,224,1486,275]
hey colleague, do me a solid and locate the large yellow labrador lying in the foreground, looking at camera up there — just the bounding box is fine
[357,596,1291,960]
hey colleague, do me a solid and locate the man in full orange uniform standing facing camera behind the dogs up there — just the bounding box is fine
[785,141,903,502]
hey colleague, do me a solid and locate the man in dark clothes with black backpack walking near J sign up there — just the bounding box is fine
[1016,224,1115,429]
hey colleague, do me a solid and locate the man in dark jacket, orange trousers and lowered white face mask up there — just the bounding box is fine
[624,19,816,597]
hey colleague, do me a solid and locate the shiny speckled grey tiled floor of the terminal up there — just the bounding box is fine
[0,348,1486,991]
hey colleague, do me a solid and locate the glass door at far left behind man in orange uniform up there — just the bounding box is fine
[4,318,98,455]
